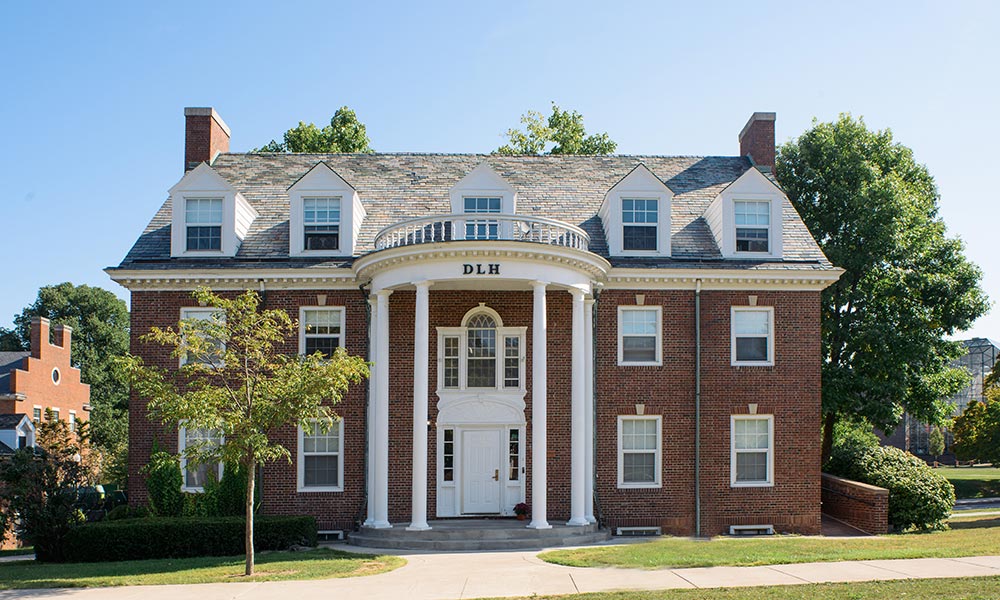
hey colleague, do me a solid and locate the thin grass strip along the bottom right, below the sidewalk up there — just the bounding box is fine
[478,577,1000,600]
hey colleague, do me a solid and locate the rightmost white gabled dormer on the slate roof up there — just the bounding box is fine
[705,169,788,259]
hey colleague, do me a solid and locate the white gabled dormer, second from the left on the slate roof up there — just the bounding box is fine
[288,162,367,256]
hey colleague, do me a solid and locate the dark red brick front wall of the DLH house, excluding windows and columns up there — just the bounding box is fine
[129,288,820,535]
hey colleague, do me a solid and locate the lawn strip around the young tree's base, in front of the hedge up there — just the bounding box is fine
[0,548,406,589]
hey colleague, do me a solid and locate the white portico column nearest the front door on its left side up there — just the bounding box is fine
[406,281,431,531]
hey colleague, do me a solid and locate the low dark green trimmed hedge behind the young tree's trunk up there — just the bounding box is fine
[60,516,317,562]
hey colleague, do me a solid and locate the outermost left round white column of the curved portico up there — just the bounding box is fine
[372,290,392,529]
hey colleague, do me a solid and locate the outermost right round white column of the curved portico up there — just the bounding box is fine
[566,288,587,527]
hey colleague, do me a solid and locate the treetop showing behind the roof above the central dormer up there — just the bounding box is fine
[496,102,618,154]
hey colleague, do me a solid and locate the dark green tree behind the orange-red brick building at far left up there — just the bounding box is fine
[14,282,129,460]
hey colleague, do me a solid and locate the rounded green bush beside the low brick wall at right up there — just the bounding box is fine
[825,438,955,531]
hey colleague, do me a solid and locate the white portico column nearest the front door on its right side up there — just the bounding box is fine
[528,281,552,529]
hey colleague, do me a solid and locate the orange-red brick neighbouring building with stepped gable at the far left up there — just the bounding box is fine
[0,317,90,437]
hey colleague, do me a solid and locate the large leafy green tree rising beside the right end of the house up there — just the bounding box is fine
[776,115,989,458]
